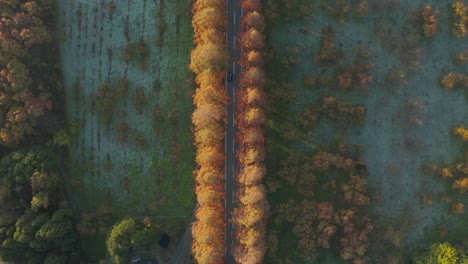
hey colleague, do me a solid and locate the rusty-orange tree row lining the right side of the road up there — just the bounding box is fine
[233,0,269,263]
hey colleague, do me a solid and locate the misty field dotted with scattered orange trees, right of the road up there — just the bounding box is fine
[263,0,468,263]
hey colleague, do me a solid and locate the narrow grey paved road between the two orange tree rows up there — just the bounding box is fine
[224,0,241,264]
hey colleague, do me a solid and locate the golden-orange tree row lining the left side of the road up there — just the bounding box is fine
[190,0,228,263]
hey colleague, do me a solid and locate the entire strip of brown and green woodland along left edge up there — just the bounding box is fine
[0,0,79,263]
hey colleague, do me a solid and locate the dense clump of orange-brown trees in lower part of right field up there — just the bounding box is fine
[273,151,374,263]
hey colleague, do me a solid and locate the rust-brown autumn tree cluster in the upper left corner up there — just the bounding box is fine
[0,0,57,147]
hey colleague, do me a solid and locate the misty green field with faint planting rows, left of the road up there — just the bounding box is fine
[57,0,194,258]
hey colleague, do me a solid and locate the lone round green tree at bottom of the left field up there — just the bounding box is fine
[106,218,156,264]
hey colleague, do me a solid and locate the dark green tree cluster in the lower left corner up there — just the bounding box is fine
[0,147,78,263]
